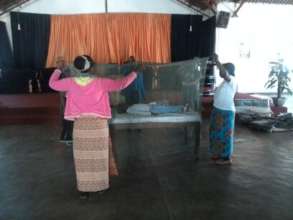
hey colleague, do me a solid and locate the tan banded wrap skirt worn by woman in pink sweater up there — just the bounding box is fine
[73,117,118,192]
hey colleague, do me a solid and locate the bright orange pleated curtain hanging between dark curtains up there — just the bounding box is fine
[47,14,171,67]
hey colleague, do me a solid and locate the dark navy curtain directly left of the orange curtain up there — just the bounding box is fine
[11,12,50,70]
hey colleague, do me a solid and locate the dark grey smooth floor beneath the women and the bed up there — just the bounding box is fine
[0,122,293,220]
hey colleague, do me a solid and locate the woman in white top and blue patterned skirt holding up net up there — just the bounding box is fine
[209,56,237,164]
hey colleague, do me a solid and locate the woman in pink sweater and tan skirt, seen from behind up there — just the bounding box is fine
[49,55,137,198]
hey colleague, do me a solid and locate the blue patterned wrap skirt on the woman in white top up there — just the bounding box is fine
[209,107,235,160]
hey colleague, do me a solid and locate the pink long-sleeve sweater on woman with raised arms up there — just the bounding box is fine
[49,69,137,120]
